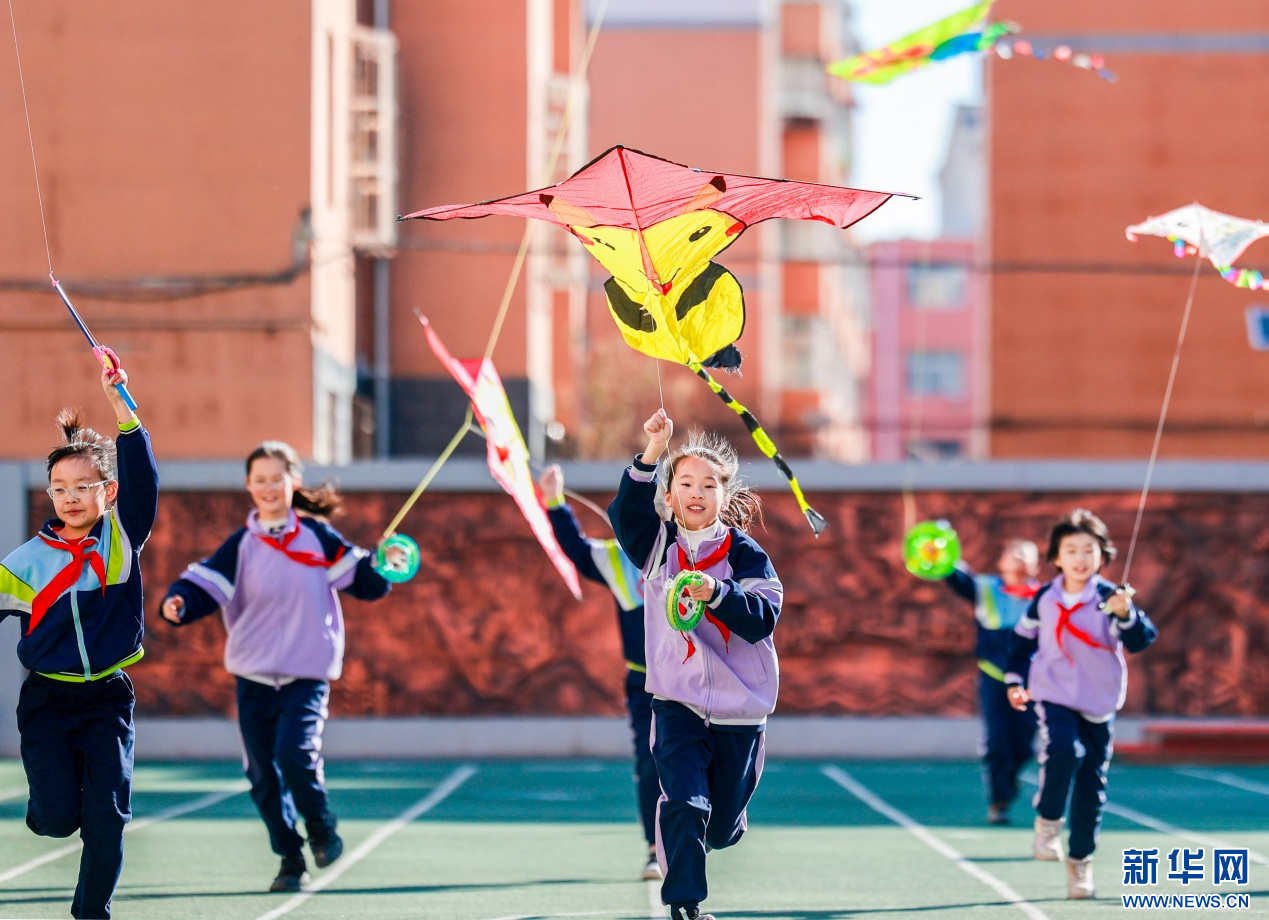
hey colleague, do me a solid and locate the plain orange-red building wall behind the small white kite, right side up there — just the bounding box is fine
[987,0,1269,458]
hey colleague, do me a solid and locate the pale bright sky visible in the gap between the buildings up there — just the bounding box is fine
[850,0,982,241]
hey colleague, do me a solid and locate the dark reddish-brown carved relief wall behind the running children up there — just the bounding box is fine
[32,490,1269,717]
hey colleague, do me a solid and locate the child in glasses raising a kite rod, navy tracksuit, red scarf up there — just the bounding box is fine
[0,368,159,917]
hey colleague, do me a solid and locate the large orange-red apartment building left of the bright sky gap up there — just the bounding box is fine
[0,0,859,464]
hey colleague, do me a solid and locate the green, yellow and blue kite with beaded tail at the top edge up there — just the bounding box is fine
[827,0,1115,85]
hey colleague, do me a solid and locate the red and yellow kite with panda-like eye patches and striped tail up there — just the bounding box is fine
[398,146,914,534]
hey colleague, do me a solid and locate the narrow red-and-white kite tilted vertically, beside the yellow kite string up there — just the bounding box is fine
[420,317,581,600]
